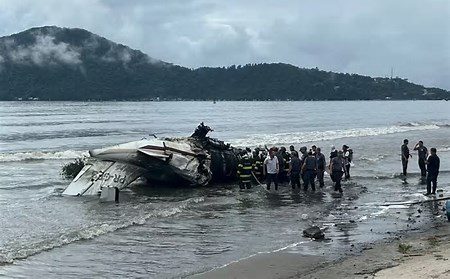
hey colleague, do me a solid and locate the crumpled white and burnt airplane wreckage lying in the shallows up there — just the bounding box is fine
[63,122,238,196]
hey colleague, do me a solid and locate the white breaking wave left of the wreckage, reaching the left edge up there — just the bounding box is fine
[0,150,89,162]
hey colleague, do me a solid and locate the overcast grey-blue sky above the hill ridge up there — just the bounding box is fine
[0,0,450,90]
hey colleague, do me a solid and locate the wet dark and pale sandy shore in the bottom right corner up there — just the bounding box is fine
[192,222,450,279]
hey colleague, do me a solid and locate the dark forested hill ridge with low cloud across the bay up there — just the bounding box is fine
[0,26,450,100]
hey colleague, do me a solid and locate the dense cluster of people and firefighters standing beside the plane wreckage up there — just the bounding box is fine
[238,145,353,192]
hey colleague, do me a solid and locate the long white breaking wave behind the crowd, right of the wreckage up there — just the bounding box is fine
[231,124,439,147]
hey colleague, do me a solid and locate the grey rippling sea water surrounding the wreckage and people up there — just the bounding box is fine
[0,101,450,278]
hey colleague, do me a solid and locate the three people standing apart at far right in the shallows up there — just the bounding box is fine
[401,139,440,195]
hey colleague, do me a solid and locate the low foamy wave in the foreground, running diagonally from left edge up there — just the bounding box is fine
[0,197,204,265]
